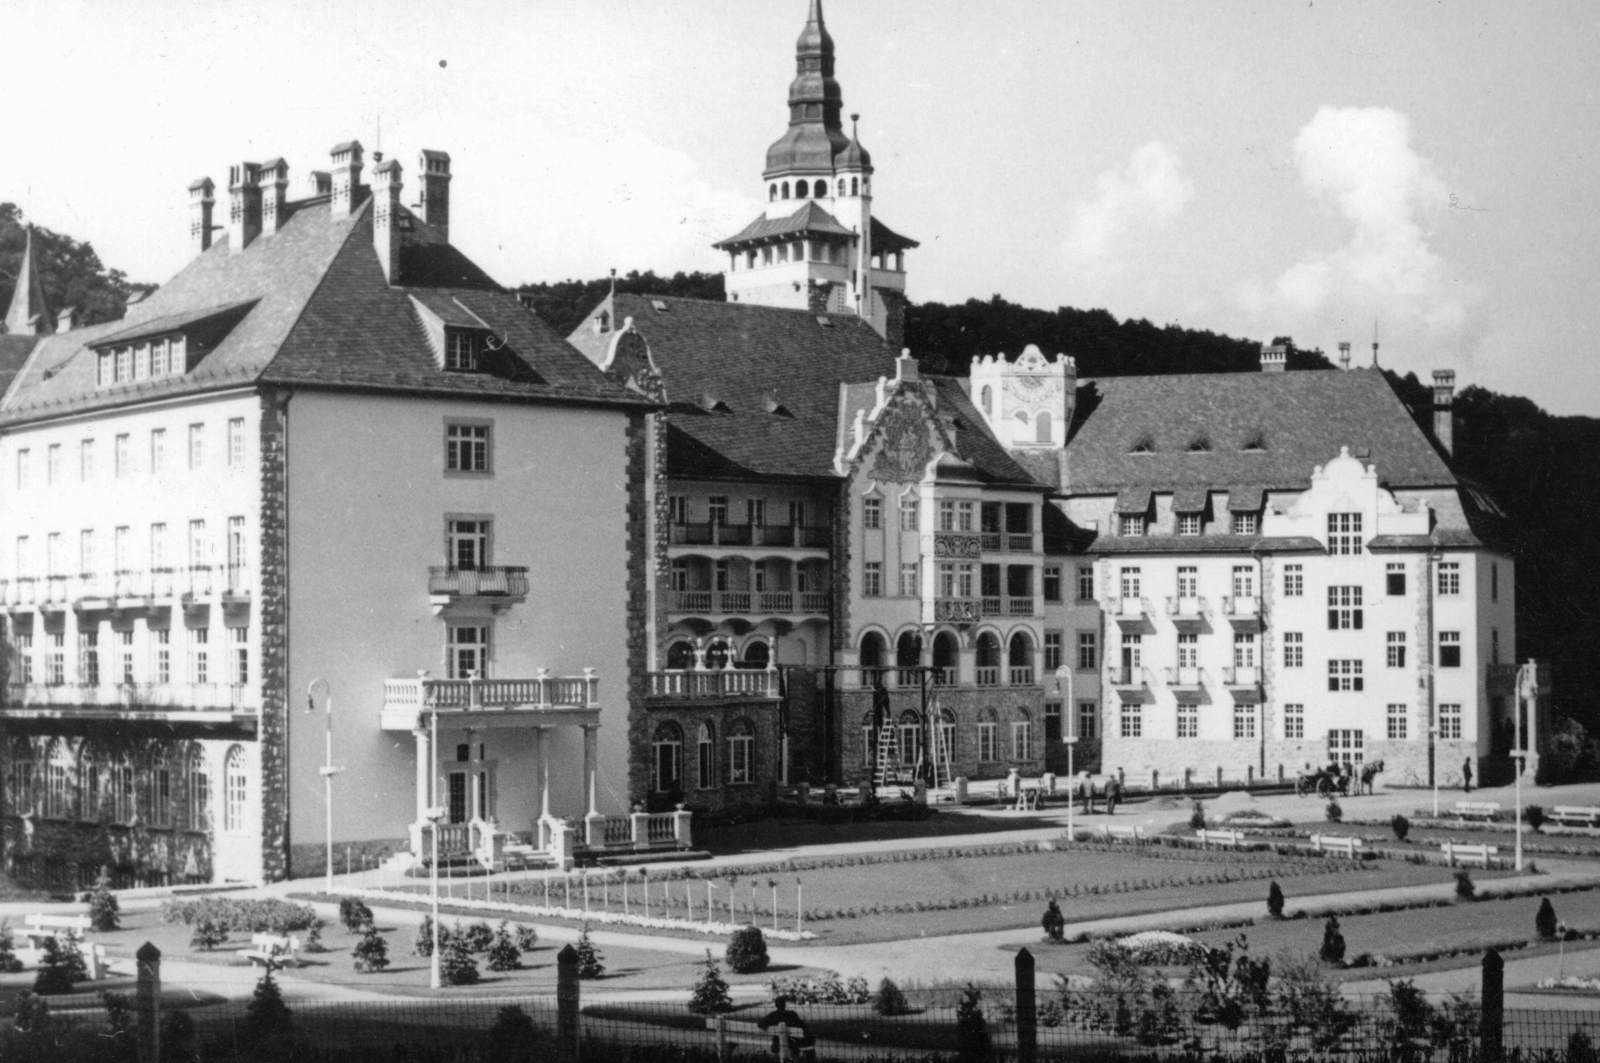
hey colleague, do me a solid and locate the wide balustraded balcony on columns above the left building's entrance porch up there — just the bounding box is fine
[379,668,600,730]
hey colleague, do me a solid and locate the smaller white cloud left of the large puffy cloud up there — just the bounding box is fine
[1062,141,1194,267]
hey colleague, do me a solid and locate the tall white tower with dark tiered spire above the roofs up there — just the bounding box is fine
[714,0,917,347]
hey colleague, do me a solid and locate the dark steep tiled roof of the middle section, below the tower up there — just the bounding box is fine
[568,295,894,477]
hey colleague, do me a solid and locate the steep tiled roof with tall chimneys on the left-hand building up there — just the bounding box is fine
[0,199,638,423]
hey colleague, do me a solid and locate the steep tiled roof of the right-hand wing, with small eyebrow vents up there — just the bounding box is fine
[1067,370,1456,493]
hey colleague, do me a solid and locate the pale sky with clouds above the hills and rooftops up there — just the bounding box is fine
[9,0,1600,415]
